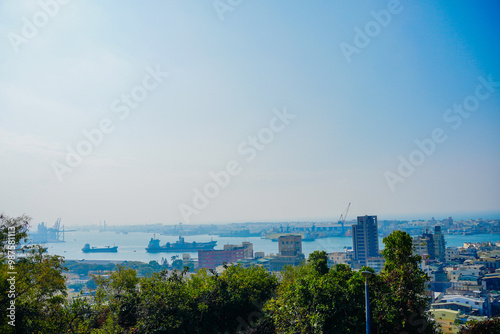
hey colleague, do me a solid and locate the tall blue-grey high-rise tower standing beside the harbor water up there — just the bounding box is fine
[352,216,379,265]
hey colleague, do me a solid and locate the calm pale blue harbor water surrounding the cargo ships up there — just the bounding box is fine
[40,231,500,262]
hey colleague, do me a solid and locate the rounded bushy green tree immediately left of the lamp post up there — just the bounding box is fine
[265,262,365,333]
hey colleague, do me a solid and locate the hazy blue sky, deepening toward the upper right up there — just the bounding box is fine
[0,0,500,226]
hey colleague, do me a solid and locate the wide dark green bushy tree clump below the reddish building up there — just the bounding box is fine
[137,266,278,334]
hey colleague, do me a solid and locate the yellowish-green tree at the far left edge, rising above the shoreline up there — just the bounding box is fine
[0,214,66,333]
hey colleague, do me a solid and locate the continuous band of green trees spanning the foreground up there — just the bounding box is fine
[0,213,450,334]
